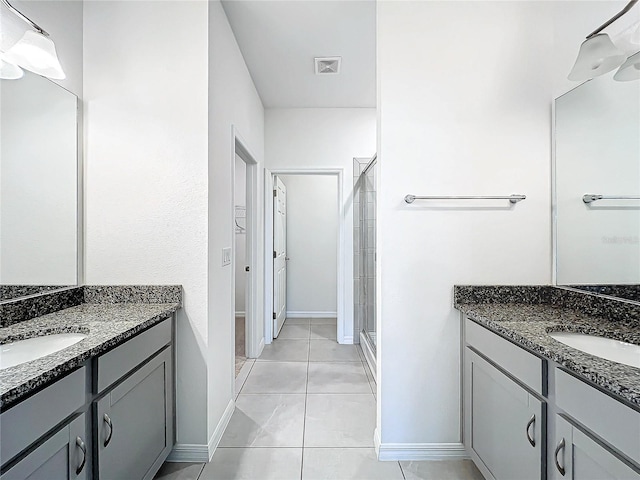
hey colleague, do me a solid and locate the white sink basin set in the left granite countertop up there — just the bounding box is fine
[0,333,87,370]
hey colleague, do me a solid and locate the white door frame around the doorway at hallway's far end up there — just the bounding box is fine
[264,168,348,344]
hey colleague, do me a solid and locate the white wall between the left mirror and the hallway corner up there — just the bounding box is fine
[84,1,210,445]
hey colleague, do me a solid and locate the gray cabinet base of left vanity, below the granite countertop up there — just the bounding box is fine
[0,317,175,480]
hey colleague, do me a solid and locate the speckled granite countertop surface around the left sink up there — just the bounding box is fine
[0,301,181,410]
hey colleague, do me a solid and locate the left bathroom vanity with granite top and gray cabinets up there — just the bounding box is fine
[0,287,181,480]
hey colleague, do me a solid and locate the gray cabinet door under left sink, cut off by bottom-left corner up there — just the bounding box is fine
[1,414,91,480]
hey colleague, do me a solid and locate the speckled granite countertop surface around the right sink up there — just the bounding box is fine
[455,293,640,409]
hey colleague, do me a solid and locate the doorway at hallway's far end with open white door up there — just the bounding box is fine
[265,169,344,343]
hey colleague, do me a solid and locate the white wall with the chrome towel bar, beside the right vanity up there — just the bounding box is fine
[377,1,553,452]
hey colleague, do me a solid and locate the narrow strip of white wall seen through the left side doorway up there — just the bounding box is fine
[233,155,247,316]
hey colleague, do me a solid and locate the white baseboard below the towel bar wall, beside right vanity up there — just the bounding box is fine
[374,442,469,461]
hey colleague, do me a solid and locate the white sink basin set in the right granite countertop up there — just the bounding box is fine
[549,332,640,368]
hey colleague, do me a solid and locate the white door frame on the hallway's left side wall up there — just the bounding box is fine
[229,125,264,362]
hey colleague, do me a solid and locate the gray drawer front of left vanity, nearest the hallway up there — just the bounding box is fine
[95,318,171,393]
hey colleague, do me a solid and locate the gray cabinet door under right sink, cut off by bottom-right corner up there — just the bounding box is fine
[551,415,640,480]
